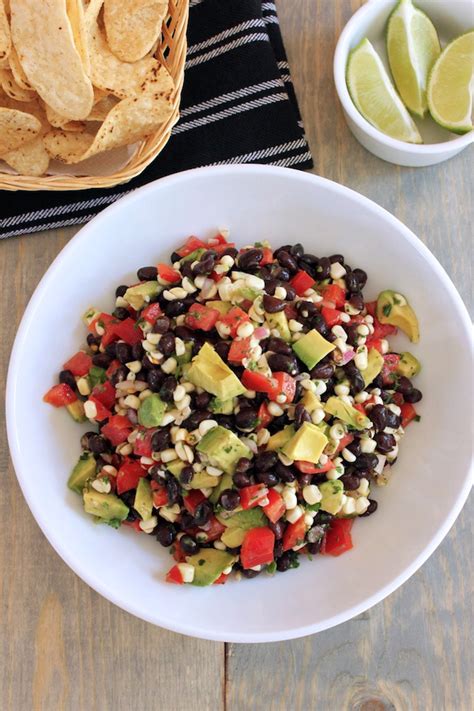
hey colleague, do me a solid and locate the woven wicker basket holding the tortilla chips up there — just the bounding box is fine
[0,0,189,190]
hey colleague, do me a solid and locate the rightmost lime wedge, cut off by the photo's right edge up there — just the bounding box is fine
[428,30,474,133]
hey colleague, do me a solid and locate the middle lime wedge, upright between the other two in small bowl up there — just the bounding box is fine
[387,0,441,118]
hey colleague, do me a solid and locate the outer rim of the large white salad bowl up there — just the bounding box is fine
[6,164,473,644]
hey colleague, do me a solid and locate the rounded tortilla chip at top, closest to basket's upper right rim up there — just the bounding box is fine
[104,0,168,62]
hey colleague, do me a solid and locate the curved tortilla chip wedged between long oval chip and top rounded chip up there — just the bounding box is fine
[86,0,160,99]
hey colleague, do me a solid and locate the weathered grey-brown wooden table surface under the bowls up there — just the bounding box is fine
[0,0,474,711]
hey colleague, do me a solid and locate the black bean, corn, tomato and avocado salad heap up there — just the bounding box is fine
[44,234,422,585]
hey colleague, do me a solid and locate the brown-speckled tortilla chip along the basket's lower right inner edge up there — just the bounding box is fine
[45,67,174,163]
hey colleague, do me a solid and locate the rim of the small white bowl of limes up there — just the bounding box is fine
[333,0,474,156]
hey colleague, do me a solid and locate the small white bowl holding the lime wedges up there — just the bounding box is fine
[334,0,474,168]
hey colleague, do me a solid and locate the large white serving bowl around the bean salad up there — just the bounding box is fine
[7,165,472,642]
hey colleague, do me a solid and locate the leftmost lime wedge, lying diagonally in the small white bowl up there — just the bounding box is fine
[346,39,422,143]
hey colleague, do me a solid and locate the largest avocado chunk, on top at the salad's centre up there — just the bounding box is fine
[186,343,245,400]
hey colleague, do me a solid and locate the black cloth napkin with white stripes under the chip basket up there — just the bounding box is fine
[0,0,313,238]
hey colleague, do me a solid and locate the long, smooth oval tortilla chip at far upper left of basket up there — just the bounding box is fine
[10,0,94,121]
